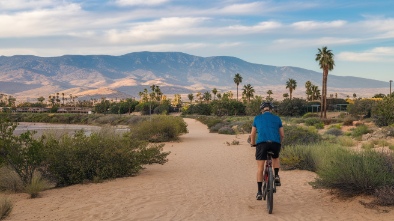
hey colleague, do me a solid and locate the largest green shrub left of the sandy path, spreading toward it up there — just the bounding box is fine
[42,130,169,186]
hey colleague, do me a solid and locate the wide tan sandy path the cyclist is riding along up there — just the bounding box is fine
[5,119,394,221]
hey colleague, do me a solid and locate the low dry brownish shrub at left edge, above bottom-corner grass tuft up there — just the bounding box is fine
[0,166,23,192]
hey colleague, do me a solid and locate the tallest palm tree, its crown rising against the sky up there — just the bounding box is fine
[315,46,335,118]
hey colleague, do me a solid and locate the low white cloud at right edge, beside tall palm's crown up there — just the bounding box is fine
[336,47,394,62]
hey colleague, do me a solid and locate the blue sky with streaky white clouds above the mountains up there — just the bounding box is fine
[0,0,394,84]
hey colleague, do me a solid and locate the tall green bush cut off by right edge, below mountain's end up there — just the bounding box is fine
[372,97,394,127]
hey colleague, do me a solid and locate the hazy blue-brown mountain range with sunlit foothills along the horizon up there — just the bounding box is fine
[0,52,387,100]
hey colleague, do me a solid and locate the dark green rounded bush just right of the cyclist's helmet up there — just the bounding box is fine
[277,98,307,116]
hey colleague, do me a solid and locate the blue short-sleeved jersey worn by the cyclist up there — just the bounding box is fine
[253,112,282,143]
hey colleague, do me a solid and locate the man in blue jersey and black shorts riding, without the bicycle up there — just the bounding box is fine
[250,102,284,200]
